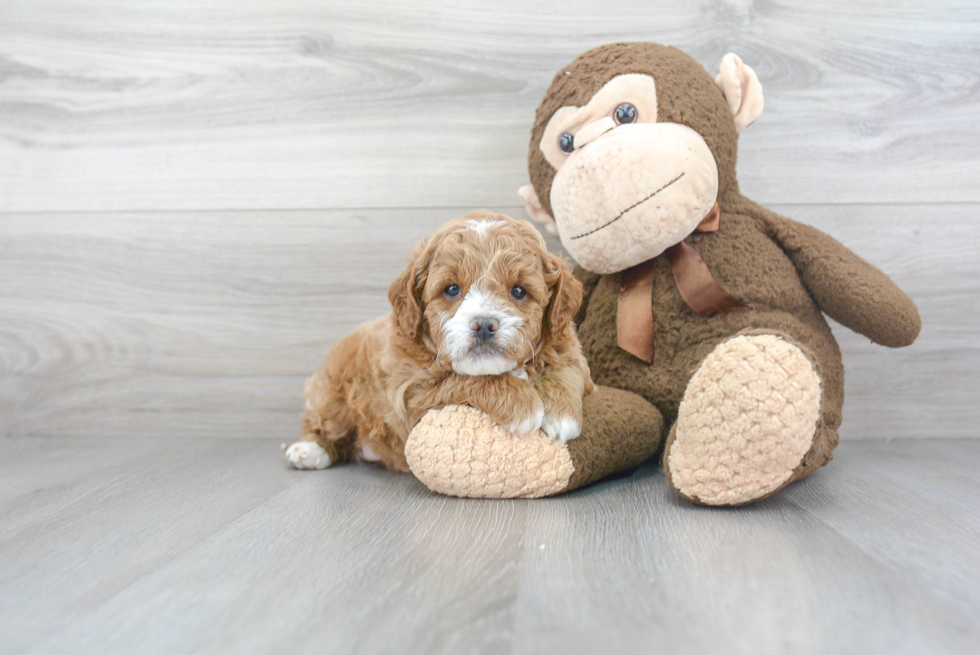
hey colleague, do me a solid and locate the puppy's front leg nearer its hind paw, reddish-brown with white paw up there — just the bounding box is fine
[456,373,544,434]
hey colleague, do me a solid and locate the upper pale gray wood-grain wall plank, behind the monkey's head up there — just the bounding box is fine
[0,0,980,211]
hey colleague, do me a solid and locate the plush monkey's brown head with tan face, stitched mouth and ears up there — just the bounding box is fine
[520,43,763,273]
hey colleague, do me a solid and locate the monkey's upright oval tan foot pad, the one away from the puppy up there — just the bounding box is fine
[663,335,821,505]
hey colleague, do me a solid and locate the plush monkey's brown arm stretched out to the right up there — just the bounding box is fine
[764,211,922,348]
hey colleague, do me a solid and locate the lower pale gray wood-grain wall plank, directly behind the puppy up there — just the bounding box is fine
[0,205,980,440]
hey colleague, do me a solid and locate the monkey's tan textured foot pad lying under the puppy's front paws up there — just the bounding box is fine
[405,405,575,498]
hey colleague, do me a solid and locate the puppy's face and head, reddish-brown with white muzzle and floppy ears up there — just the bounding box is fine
[389,212,581,375]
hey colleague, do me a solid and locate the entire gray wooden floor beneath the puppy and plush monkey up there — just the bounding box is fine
[0,438,980,655]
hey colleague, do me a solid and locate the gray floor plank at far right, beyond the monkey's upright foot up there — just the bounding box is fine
[790,440,980,614]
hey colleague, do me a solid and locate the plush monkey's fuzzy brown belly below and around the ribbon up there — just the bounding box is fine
[578,218,843,427]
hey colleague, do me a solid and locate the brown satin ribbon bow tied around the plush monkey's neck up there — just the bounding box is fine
[616,202,744,364]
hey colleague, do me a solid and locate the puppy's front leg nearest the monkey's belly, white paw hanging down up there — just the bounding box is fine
[534,359,595,443]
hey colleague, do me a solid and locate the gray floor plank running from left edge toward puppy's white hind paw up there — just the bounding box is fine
[0,439,295,600]
